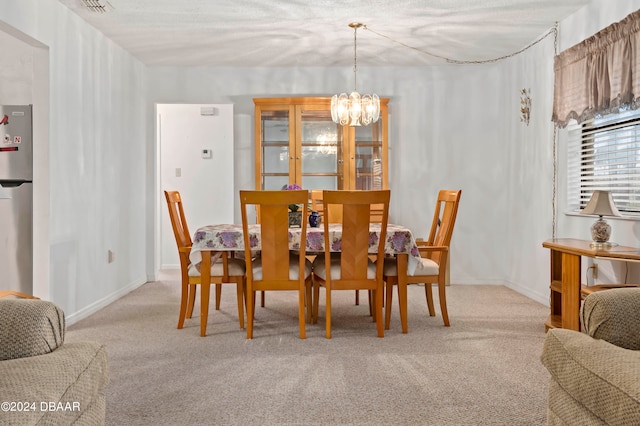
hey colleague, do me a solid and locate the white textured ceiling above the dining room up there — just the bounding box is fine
[59,0,590,67]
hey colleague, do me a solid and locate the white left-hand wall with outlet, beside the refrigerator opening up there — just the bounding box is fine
[0,0,148,323]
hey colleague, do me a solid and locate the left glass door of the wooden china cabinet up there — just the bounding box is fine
[258,109,290,190]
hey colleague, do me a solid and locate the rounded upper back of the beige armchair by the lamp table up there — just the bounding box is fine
[580,288,640,350]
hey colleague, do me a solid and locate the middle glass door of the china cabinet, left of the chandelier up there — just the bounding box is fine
[296,106,344,190]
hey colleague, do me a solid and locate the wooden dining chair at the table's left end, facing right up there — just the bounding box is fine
[164,191,245,336]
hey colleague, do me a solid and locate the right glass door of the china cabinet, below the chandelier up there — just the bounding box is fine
[354,118,385,190]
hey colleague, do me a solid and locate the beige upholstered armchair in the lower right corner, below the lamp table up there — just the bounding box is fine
[541,288,640,426]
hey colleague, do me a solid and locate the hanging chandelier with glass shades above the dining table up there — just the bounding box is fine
[331,22,380,126]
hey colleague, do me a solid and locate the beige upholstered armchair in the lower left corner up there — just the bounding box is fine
[0,298,109,426]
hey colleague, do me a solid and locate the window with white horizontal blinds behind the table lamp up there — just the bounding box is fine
[568,110,640,216]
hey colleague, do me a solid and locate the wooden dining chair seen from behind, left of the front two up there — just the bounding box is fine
[240,190,312,339]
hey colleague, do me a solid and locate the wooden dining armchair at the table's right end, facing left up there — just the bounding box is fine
[384,189,462,333]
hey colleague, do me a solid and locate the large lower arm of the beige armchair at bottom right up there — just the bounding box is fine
[541,329,640,425]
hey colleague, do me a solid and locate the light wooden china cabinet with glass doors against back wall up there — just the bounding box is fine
[253,97,389,190]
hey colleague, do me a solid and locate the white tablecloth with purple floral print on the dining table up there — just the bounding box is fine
[189,223,420,271]
